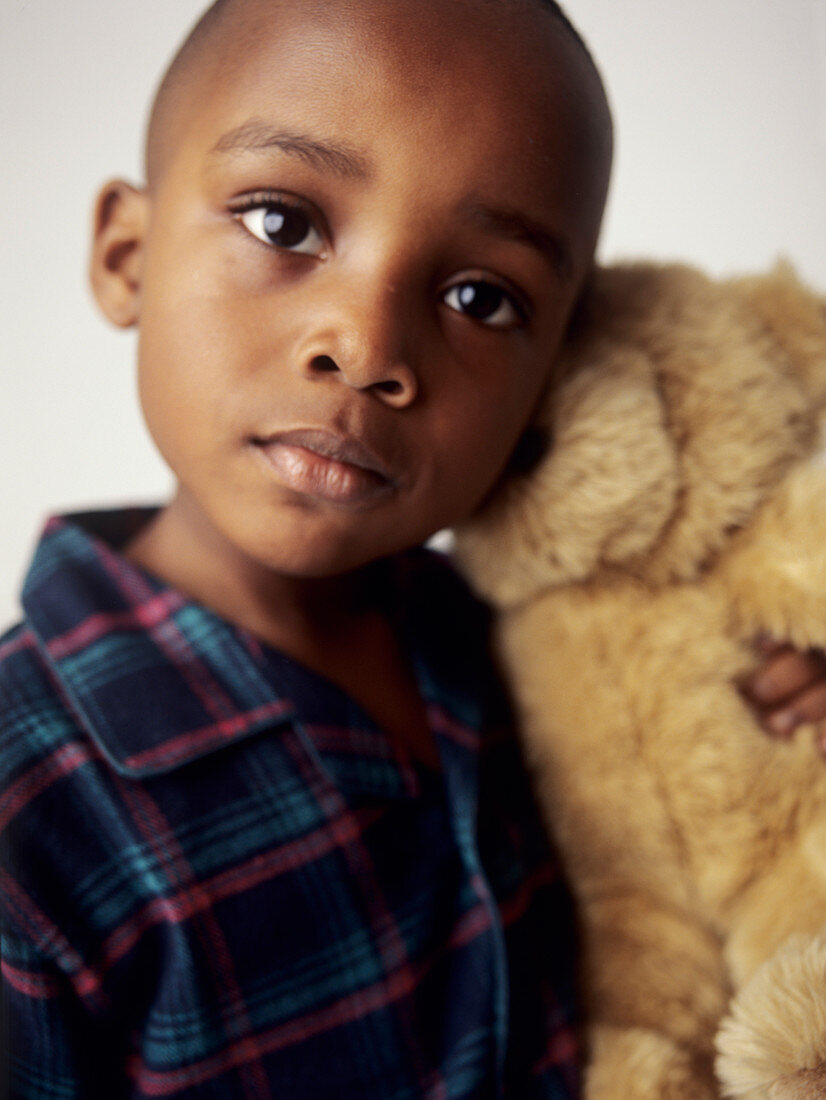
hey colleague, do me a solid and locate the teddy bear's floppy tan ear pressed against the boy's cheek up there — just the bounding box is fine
[456,327,678,607]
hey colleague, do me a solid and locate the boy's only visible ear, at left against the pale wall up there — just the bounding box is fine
[89,179,150,328]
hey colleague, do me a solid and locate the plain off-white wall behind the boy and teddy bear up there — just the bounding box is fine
[0,0,826,623]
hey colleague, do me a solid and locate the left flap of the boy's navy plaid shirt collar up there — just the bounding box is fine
[22,509,294,778]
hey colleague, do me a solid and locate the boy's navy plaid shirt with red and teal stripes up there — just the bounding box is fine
[0,510,579,1100]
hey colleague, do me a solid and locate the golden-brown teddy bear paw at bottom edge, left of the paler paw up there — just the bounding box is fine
[585,1027,718,1100]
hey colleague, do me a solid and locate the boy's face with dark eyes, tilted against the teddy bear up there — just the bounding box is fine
[95,0,604,576]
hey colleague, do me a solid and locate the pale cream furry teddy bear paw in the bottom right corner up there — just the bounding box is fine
[716,933,826,1100]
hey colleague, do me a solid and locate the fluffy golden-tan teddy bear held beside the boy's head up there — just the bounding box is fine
[455,264,826,1100]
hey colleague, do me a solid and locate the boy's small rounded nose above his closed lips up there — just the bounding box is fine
[300,283,419,408]
